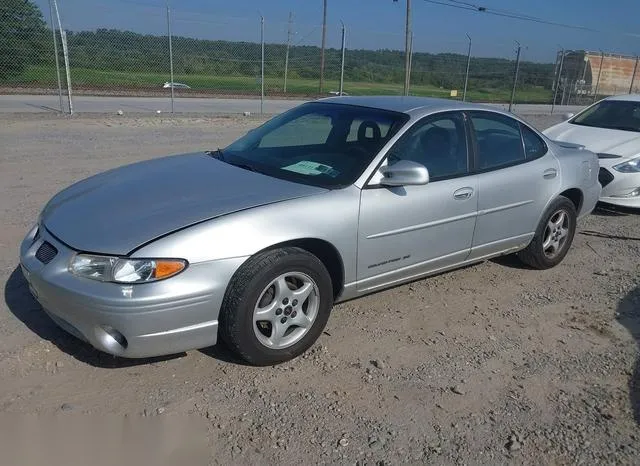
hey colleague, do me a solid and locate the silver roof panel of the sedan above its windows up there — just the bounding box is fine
[318,96,502,116]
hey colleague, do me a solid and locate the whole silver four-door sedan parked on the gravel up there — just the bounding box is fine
[20,97,601,365]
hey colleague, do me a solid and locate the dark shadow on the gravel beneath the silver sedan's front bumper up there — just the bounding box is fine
[4,267,185,369]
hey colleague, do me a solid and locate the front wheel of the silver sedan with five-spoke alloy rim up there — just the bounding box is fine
[219,247,333,366]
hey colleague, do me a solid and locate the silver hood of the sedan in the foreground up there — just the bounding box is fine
[41,153,326,255]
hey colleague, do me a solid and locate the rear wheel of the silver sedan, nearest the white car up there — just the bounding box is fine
[517,196,577,270]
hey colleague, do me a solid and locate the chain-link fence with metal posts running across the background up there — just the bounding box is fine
[0,0,640,111]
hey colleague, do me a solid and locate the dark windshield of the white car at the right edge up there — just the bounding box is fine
[570,100,640,132]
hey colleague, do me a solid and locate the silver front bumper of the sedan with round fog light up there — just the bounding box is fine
[20,228,245,358]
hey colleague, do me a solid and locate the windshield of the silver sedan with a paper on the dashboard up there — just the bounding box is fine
[222,102,409,188]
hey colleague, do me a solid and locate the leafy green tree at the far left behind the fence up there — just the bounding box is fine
[0,0,48,80]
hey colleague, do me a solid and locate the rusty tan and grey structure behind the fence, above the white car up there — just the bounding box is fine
[553,50,640,103]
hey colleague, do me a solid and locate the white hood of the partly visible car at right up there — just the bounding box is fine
[544,122,640,158]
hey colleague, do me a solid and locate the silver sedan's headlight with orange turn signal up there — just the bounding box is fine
[69,254,187,283]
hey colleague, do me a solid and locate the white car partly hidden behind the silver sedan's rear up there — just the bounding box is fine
[544,94,640,208]
